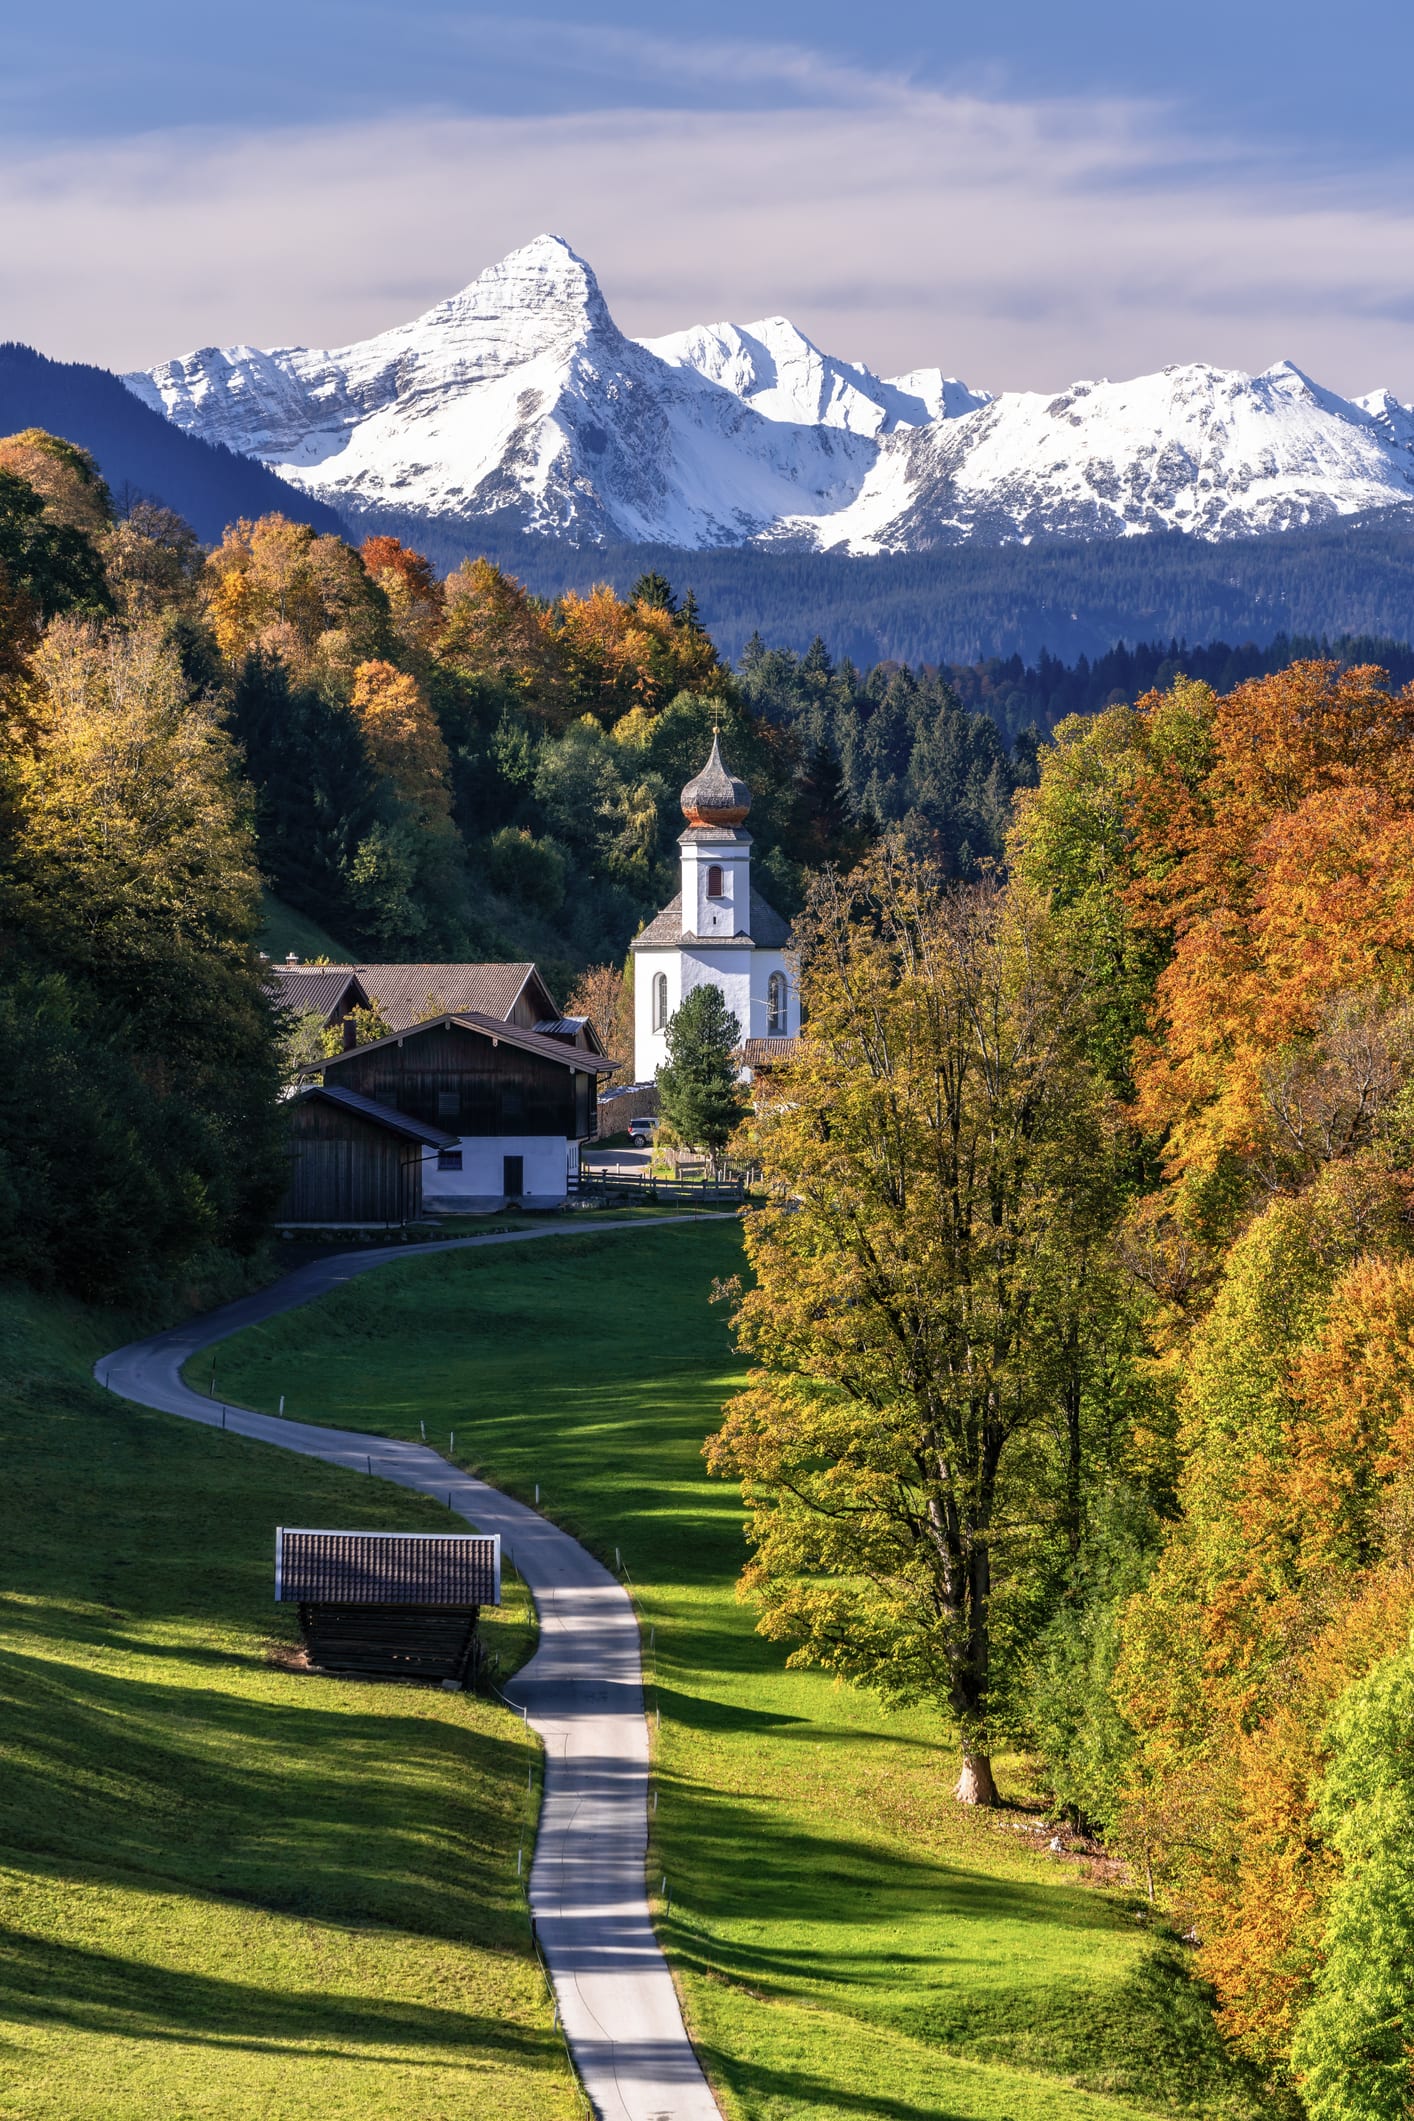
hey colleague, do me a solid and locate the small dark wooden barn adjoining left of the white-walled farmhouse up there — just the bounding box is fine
[276,1084,456,1228]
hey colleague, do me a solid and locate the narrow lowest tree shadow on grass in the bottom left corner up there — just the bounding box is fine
[0,1926,562,2072]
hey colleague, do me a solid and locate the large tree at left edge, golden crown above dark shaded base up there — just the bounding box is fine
[0,619,284,1298]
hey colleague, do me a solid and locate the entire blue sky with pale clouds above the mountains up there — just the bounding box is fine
[0,0,1414,399]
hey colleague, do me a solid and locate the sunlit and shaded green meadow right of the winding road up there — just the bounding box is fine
[204,1224,1280,2121]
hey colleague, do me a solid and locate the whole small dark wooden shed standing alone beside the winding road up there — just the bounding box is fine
[276,1525,500,1684]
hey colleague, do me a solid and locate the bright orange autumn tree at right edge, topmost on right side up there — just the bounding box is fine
[1126,662,1414,1177]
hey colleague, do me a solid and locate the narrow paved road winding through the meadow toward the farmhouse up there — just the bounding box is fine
[93,1215,729,2121]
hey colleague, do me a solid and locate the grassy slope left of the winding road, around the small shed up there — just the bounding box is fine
[0,1292,579,2121]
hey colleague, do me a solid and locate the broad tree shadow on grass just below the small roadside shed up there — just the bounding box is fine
[0,1652,526,1941]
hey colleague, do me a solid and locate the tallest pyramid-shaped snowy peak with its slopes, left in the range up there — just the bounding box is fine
[125,235,873,545]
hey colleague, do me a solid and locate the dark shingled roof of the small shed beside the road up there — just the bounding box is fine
[276,1525,500,1606]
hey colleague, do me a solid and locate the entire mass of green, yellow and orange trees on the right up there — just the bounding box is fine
[710,662,1414,2121]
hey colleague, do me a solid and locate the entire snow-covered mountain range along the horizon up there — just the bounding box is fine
[125,235,1414,551]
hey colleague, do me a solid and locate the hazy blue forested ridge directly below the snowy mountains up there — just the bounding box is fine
[367,511,1414,668]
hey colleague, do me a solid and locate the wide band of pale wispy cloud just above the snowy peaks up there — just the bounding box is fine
[0,58,1414,397]
